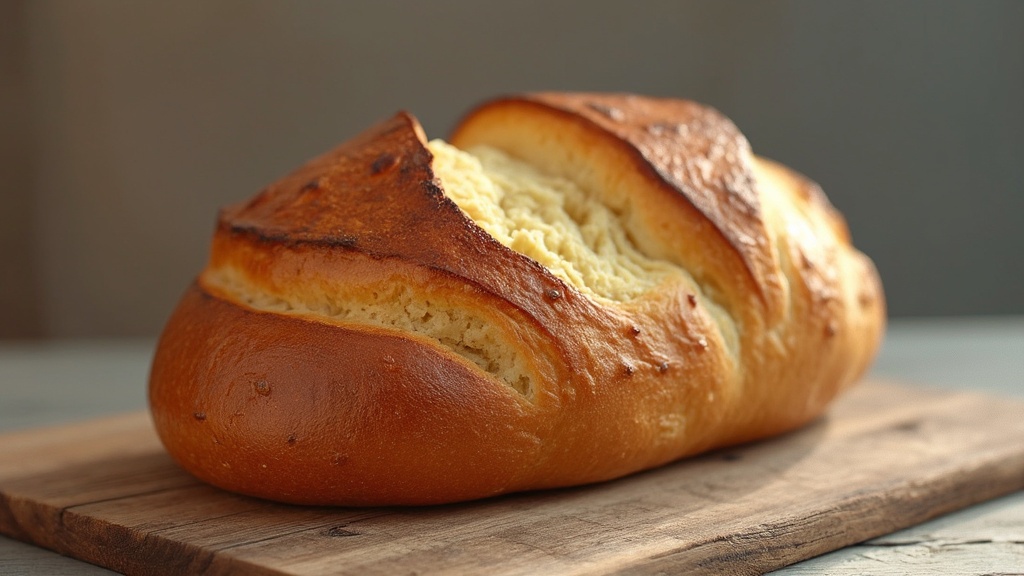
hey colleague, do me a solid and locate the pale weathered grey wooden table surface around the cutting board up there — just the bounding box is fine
[0,317,1024,576]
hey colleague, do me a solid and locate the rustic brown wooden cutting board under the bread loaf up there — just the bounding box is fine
[0,382,1024,575]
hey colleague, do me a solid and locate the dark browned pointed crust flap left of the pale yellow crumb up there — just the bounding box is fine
[219,113,577,332]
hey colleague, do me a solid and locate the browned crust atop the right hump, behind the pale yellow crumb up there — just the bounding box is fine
[473,93,790,307]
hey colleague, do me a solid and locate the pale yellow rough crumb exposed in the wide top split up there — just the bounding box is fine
[427,140,681,301]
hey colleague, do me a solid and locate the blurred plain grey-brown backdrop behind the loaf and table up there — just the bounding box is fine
[0,0,1024,338]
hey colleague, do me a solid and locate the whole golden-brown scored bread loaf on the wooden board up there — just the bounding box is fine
[150,93,885,505]
